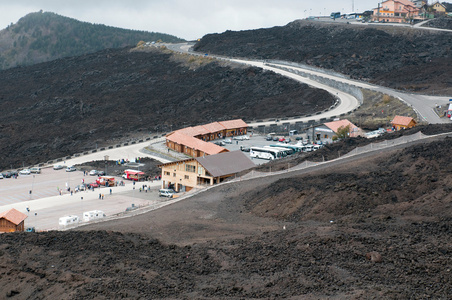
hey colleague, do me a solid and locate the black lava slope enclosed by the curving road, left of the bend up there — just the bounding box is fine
[0,47,335,169]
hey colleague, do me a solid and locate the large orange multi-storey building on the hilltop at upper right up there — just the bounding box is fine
[372,0,422,23]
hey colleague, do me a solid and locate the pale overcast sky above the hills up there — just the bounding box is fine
[0,0,379,40]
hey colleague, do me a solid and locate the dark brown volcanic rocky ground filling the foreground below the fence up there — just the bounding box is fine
[0,132,452,299]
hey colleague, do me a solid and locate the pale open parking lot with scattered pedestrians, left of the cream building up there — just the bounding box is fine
[0,167,167,230]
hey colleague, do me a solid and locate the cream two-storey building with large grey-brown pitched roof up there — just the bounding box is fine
[159,151,255,192]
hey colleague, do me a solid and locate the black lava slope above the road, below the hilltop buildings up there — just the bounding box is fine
[194,20,452,95]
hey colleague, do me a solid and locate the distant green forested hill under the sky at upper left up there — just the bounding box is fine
[0,11,183,70]
